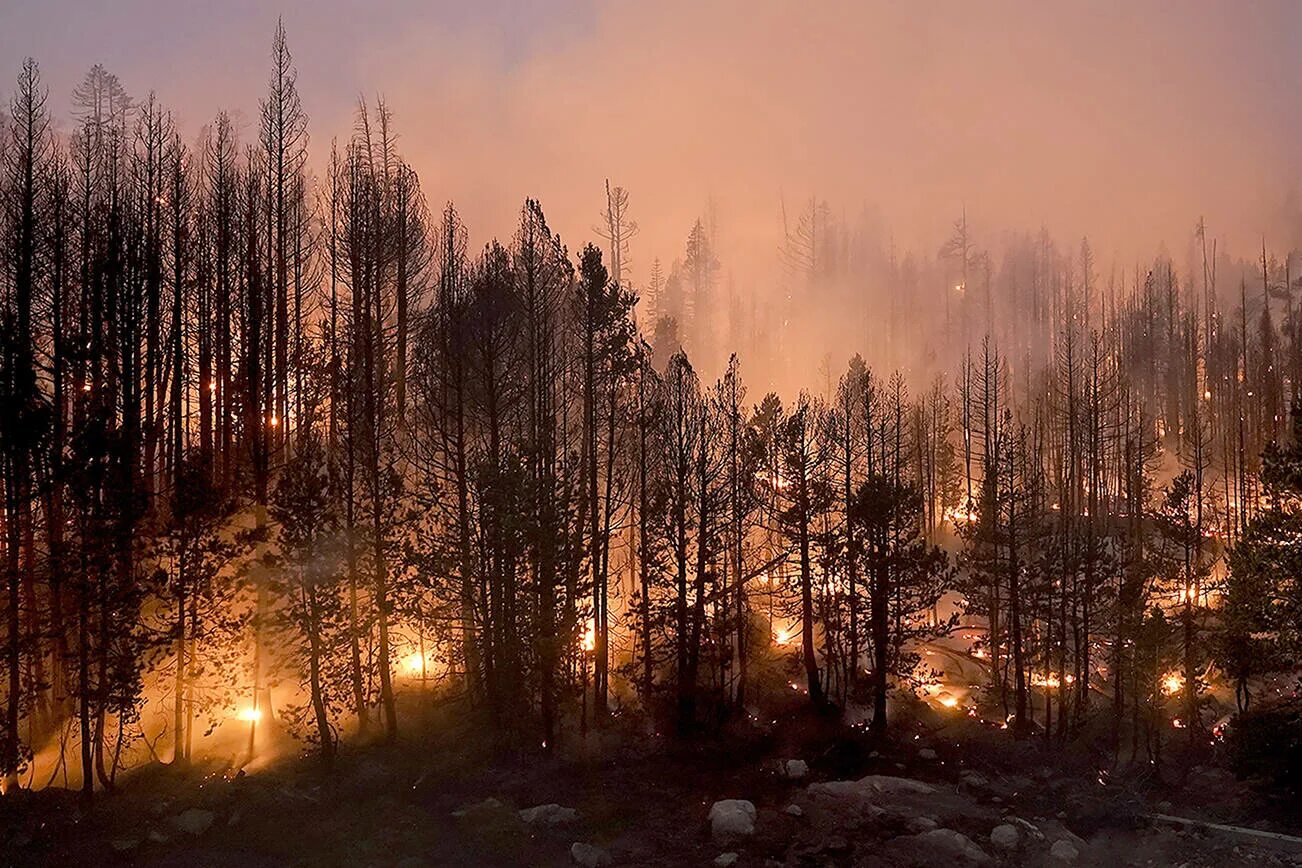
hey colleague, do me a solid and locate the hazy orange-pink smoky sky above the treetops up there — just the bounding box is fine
[0,0,1302,282]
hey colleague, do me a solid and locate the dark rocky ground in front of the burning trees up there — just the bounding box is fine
[0,697,1302,868]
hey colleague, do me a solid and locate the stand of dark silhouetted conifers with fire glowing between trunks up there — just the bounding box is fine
[0,29,1302,796]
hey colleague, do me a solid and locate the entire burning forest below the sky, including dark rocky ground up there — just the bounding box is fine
[0,4,1302,868]
